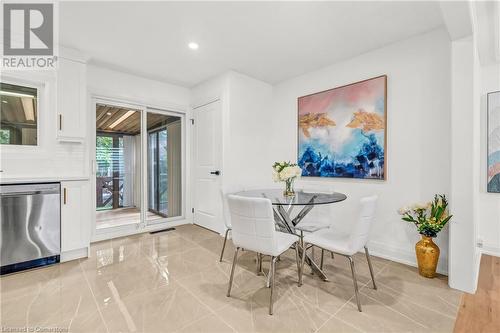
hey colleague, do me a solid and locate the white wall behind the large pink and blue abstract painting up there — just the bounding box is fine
[272,30,450,272]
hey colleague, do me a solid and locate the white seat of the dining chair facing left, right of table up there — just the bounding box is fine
[304,228,356,256]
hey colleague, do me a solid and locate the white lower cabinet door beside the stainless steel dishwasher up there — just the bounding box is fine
[61,181,90,252]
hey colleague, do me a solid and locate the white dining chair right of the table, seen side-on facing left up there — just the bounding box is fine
[299,196,377,312]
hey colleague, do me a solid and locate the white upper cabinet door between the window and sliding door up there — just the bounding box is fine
[57,58,87,142]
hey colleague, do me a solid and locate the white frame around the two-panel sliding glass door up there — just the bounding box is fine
[88,93,191,242]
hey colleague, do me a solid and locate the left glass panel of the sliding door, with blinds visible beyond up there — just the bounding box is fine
[95,103,142,229]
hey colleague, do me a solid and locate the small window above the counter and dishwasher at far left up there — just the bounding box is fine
[0,82,38,146]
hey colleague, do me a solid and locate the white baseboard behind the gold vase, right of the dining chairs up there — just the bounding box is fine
[368,241,448,275]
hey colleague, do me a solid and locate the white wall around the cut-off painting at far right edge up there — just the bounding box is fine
[478,64,500,256]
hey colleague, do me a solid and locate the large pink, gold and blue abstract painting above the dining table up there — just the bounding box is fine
[298,75,387,180]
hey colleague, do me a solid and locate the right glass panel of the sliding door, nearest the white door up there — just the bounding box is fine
[147,110,182,223]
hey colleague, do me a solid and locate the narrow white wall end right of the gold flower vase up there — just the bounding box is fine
[448,37,479,293]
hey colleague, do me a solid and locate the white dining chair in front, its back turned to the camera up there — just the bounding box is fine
[227,195,300,315]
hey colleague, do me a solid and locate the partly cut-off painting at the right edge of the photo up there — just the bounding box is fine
[487,91,500,193]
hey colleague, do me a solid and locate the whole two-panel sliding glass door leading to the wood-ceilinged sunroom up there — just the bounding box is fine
[95,101,184,235]
